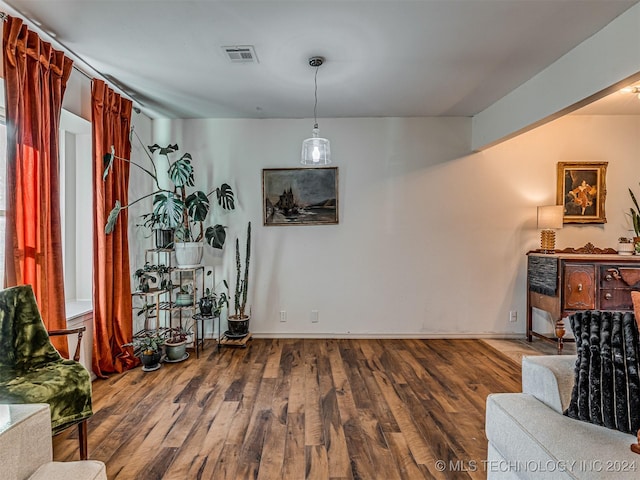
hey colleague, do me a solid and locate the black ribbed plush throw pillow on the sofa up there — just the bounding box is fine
[565,311,640,434]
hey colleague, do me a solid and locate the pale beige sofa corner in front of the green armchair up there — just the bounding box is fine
[0,404,107,480]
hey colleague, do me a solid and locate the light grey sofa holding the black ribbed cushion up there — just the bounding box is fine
[485,355,640,480]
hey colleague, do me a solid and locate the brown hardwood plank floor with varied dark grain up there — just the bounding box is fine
[54,339,520,480]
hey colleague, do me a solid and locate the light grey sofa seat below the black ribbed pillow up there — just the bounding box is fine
[484,393,640,480]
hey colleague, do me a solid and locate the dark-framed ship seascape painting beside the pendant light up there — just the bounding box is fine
[262,167,338,226]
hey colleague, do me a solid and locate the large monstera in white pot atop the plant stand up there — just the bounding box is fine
[103,144,235,267]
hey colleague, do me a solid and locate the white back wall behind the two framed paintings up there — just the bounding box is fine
[141,116,640,337]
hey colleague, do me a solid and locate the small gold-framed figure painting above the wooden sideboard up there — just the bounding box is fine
[557,162,607,223]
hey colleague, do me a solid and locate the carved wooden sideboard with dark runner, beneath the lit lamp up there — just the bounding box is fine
[527,252,640,352]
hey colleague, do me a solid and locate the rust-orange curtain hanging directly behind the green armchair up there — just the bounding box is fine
[3,17,73,356]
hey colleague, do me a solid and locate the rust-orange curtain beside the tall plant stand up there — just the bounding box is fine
[91,79,138,377]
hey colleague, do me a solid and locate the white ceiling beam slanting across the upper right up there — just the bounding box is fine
[471,4,640,151]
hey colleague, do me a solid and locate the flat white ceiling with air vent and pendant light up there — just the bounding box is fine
[2,0,640,118]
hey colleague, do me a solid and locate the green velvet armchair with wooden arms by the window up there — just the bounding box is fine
[0,285,93,460]
